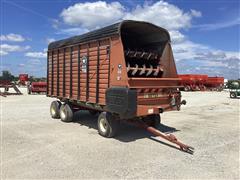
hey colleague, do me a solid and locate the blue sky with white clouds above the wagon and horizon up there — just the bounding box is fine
[0,0,240,79]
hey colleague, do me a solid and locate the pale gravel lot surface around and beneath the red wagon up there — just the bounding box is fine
[1,89,240,179]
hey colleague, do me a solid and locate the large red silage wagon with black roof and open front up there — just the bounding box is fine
[47,20,193,153]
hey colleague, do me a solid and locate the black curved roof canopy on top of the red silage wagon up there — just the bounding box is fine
[48,20,170,50]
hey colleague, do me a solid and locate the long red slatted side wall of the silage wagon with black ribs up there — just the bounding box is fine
[47,39,110,105]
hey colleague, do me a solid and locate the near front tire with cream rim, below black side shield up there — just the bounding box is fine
[98,112,119,138]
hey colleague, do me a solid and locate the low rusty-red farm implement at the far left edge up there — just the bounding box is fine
[0,80,22,97]
